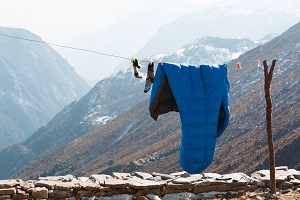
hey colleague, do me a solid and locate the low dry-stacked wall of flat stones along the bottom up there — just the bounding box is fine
[0,167,300,200]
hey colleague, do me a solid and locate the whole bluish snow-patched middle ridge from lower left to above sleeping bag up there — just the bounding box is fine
[0,38,257,178]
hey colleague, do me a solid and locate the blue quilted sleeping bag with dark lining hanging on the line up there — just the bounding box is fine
[149,63,230,174]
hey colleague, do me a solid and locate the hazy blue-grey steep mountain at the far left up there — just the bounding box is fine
[0,27,89,150]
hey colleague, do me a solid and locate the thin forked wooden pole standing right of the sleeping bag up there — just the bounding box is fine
[263,60,276,194]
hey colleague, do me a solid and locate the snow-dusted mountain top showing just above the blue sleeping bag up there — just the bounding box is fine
[153,37,261,65]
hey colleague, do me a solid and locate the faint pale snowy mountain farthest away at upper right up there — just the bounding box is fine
[137,0,300,61]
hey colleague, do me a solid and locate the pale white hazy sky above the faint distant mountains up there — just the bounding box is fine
[0,0,210,44]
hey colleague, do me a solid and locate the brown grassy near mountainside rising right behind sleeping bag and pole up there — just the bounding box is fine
[14,23,300,179]
